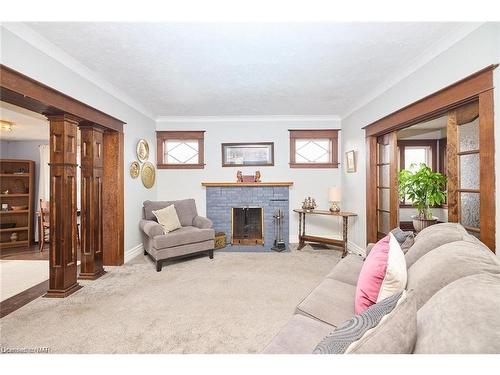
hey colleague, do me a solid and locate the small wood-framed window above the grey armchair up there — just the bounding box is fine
[156,131,205,169]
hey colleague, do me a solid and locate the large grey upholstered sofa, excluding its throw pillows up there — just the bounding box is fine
[264,223,500,354]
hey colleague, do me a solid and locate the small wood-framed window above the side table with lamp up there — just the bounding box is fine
[290,129,338,168]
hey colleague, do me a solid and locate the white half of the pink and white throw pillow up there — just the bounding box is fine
[377,233,408,302]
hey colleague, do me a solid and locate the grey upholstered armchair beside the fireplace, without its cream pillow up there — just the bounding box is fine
[139,199,215,272]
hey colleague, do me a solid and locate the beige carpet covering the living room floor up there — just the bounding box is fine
[0,246,340,353]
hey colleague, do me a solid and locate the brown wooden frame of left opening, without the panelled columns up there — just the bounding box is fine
[0,64,125,266]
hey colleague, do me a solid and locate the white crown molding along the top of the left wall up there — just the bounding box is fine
[0,22,155,120]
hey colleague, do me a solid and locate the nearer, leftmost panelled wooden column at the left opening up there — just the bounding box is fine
[45,115,81,298]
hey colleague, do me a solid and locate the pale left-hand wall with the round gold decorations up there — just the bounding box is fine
[0,27,156,254]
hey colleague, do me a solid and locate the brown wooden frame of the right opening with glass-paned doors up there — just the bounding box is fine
[363,64,498,252]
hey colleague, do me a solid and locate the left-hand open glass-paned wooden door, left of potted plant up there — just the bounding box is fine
[376,132,399,239]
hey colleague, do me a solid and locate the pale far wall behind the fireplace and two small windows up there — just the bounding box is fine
[157,118,342,242]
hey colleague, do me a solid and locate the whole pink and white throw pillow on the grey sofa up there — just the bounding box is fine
[354,234,407,314]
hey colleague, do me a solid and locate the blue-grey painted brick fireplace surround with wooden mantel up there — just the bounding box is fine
[202,182,292,251]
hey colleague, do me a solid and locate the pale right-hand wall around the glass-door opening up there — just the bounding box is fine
[342,23,500,254]
